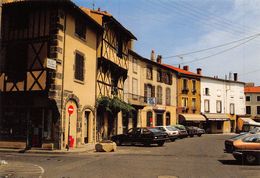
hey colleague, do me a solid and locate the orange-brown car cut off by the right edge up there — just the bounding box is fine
[225,133,260,164]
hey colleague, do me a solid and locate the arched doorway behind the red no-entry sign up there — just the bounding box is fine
[64,100,78,148]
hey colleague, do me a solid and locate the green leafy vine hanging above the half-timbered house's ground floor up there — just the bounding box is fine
[97,96,135,115]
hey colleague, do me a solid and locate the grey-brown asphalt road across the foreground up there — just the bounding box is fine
[0,135,260,178]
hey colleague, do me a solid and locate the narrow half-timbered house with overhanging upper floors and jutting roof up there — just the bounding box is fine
[82,8,136,140]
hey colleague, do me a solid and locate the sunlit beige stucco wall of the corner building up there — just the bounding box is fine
[60,15,97,147]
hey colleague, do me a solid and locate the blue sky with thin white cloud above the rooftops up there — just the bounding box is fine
[73,0,260,85]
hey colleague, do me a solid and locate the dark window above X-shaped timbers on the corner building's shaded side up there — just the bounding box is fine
[6,43,28,81]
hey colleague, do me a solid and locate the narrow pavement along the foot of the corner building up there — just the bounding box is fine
[0,144,95,154]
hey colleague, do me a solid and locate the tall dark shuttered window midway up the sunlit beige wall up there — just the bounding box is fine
[74,52,85,81]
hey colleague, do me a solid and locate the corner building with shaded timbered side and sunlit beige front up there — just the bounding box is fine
[0,0,102,149]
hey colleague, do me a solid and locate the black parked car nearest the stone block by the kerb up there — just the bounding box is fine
[111,127,169,146]
